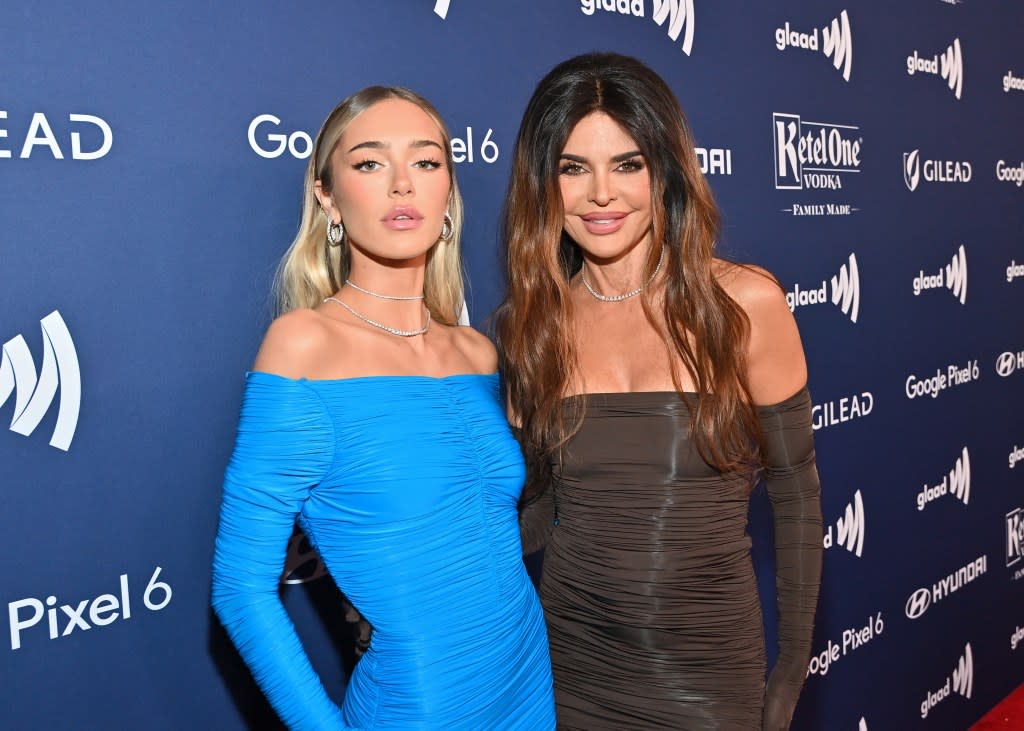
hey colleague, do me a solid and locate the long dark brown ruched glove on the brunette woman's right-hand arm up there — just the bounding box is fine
[758,387,822,731]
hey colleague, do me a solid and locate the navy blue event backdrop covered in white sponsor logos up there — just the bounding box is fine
[0,0,1024,731]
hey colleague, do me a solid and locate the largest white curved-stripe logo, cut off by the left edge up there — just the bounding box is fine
[0,310,82,452]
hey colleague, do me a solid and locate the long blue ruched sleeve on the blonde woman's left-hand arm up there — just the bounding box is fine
[212,374,348,731]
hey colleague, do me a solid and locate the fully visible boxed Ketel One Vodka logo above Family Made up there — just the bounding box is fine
[772,112,863,190]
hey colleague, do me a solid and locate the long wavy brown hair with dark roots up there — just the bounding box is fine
[496,53,761,501]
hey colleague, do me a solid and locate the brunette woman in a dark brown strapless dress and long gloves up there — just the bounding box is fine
[498,53,822,731]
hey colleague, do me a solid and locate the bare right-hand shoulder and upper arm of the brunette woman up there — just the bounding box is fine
[714,260,807,404]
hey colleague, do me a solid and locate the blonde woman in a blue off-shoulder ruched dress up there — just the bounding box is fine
[213,87,554,731]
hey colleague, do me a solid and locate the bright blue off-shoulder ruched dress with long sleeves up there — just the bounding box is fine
[212,373,555,731]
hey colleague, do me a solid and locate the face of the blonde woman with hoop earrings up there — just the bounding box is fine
[316,98,452,260]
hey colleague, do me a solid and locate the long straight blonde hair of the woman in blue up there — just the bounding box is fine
[273,86,464,325]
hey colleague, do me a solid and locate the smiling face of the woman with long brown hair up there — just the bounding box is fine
[558,112,651,259]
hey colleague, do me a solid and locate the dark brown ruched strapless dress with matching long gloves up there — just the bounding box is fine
[520,388,822,731]
